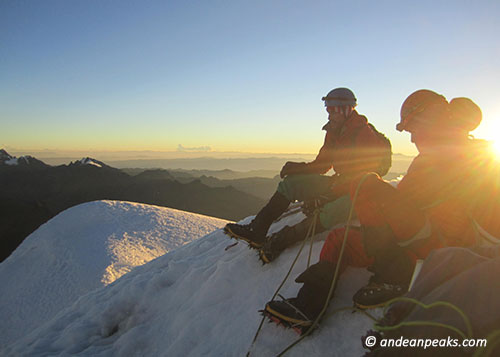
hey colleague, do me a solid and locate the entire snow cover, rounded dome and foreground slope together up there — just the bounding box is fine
[0,201,380,356]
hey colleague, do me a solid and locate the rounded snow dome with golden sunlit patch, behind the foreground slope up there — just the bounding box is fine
[0,201,226,346]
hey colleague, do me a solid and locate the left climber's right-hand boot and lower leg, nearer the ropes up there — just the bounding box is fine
[259,216,325,263]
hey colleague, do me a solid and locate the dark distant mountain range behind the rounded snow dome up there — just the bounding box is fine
[0,149,268,260]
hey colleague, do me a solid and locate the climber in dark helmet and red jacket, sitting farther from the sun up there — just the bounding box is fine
[224,88,391,263]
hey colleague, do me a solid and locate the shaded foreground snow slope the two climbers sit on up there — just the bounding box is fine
[0,206,380,356]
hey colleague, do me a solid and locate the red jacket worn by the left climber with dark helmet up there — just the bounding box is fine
[301,111,385,177]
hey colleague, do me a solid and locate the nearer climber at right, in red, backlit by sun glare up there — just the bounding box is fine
[265,90,500,327]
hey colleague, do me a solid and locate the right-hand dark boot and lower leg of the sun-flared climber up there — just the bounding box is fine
[353,225,415,309]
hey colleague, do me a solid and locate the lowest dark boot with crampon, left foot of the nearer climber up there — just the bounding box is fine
[264,261,335,327]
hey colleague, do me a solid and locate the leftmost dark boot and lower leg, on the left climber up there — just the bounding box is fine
[224,192,290,249]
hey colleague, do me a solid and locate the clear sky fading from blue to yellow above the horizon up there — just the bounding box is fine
[0,0,500,155]
